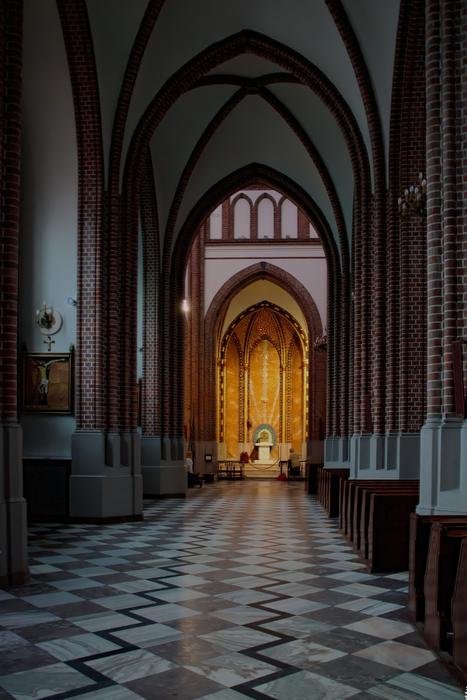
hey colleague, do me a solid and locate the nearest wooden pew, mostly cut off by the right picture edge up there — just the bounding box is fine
[452,538,467,687]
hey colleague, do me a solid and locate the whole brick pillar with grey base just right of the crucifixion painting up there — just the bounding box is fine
[58,0,142,521]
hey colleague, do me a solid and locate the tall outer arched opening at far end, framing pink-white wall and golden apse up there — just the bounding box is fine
[183,183,329,476]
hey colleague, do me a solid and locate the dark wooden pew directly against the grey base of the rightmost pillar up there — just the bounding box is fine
[407,513,467,622]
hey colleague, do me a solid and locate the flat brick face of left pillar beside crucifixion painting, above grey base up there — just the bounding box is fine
[58,0,105,429]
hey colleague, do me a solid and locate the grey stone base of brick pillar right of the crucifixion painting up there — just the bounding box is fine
[70,430,143,522]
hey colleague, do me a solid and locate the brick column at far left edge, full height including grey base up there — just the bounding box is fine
[0,0,28,586]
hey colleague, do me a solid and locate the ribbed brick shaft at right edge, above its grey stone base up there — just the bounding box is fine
[426,0,467,416]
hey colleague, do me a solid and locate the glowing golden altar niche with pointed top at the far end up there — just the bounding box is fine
[217,301,308,468]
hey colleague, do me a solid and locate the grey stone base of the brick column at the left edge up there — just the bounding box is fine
[0,425,29,586]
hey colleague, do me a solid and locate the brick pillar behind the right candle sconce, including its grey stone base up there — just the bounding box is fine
[386,0,426,478]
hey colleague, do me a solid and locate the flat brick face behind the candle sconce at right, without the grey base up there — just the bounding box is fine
[391,0,426,432]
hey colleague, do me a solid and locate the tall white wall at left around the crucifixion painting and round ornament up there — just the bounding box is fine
[19,0,78,457]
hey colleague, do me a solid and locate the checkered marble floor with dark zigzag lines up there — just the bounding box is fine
[0,480,464,700]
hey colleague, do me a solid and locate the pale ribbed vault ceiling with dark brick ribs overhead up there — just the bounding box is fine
[87,0,399,258]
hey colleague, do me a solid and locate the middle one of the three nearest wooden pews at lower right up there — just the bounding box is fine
[423,522,467,653]
